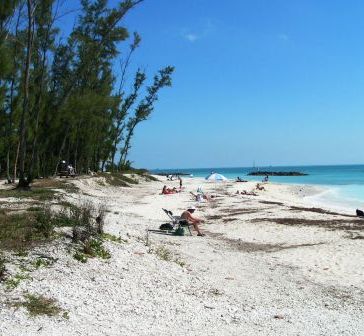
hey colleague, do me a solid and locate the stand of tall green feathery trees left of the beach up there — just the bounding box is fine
[0,0,174,181]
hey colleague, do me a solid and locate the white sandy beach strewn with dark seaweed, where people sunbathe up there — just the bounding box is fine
[0,177,364,336]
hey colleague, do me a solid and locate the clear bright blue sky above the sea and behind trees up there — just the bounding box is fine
[59,0,364,169]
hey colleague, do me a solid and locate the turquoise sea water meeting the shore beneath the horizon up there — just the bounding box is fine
[153,165,364,207]
